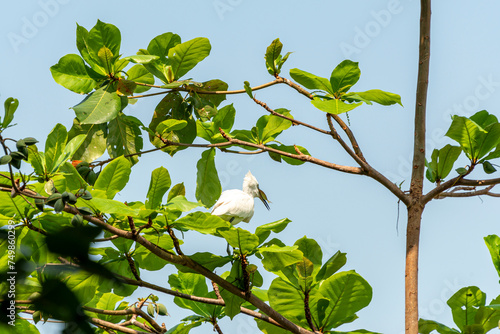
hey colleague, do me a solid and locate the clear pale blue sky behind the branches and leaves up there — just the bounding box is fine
[0,0,500,334]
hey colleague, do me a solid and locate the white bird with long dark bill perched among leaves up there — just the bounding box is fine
[212,172,269,225]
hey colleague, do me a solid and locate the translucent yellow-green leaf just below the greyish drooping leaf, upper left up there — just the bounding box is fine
[68,118,108,162]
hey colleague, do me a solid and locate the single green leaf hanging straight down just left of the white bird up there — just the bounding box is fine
[196,148,222,208]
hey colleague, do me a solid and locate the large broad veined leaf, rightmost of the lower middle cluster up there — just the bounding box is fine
[318,270,372,330]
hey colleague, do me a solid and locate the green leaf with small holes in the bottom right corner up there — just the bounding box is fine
[447,286,486,331]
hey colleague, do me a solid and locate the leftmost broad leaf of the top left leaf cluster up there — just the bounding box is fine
[50,54,101,94]
